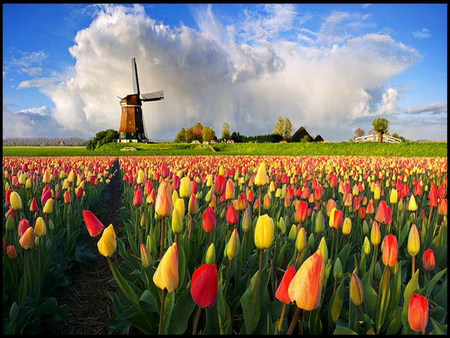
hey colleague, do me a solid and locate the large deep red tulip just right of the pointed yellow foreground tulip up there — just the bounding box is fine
[191,264,219,308]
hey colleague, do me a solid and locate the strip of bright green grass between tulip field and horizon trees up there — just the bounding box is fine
[3,142,447,157]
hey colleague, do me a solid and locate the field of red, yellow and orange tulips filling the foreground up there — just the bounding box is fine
[2,155,448,335]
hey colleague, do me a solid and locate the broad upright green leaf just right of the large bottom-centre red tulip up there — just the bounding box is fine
[241,270,261,334]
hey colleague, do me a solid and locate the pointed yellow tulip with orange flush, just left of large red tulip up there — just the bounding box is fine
[153,243,178,292]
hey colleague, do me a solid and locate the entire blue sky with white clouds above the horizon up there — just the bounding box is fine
[3,4,448,141]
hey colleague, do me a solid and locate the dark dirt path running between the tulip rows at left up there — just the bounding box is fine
[41,160,122,335]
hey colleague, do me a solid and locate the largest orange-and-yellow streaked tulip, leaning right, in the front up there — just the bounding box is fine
[288,252,325,311]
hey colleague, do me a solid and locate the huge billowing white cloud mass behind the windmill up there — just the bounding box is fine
[14,4,440,141]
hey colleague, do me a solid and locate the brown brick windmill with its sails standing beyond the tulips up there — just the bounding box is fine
[119,58,164,142]
